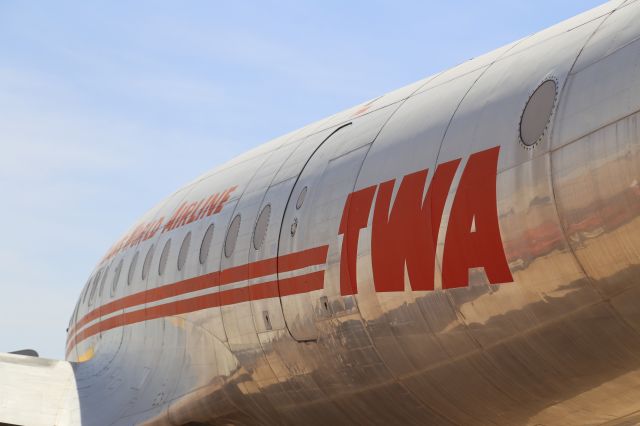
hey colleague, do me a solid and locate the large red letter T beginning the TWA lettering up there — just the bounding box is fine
[339,186,376,296]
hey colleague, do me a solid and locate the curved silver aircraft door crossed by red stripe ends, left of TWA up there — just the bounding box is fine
[278,115,388,342]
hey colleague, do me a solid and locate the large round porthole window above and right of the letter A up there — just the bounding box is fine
[520,80,558,147]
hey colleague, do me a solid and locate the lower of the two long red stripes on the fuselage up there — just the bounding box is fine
[67,271,324,356]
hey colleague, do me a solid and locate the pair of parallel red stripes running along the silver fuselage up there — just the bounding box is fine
[67,246,329,355]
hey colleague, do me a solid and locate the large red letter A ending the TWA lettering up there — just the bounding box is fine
[442,147,513,289]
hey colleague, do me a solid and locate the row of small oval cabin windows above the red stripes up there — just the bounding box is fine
[82,203,276,306]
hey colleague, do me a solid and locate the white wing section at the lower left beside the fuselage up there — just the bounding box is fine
[0,351,80,426]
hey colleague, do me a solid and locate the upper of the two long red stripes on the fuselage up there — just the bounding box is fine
[68,245,329,352]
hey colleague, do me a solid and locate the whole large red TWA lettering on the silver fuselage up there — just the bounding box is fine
[339,146,513,295]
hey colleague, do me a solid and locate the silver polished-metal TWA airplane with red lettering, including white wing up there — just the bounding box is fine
[0,0,640,425]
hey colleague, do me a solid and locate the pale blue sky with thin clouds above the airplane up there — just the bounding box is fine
[0,0,602,358]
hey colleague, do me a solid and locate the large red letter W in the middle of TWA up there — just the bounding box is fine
[371,160,460,292]
